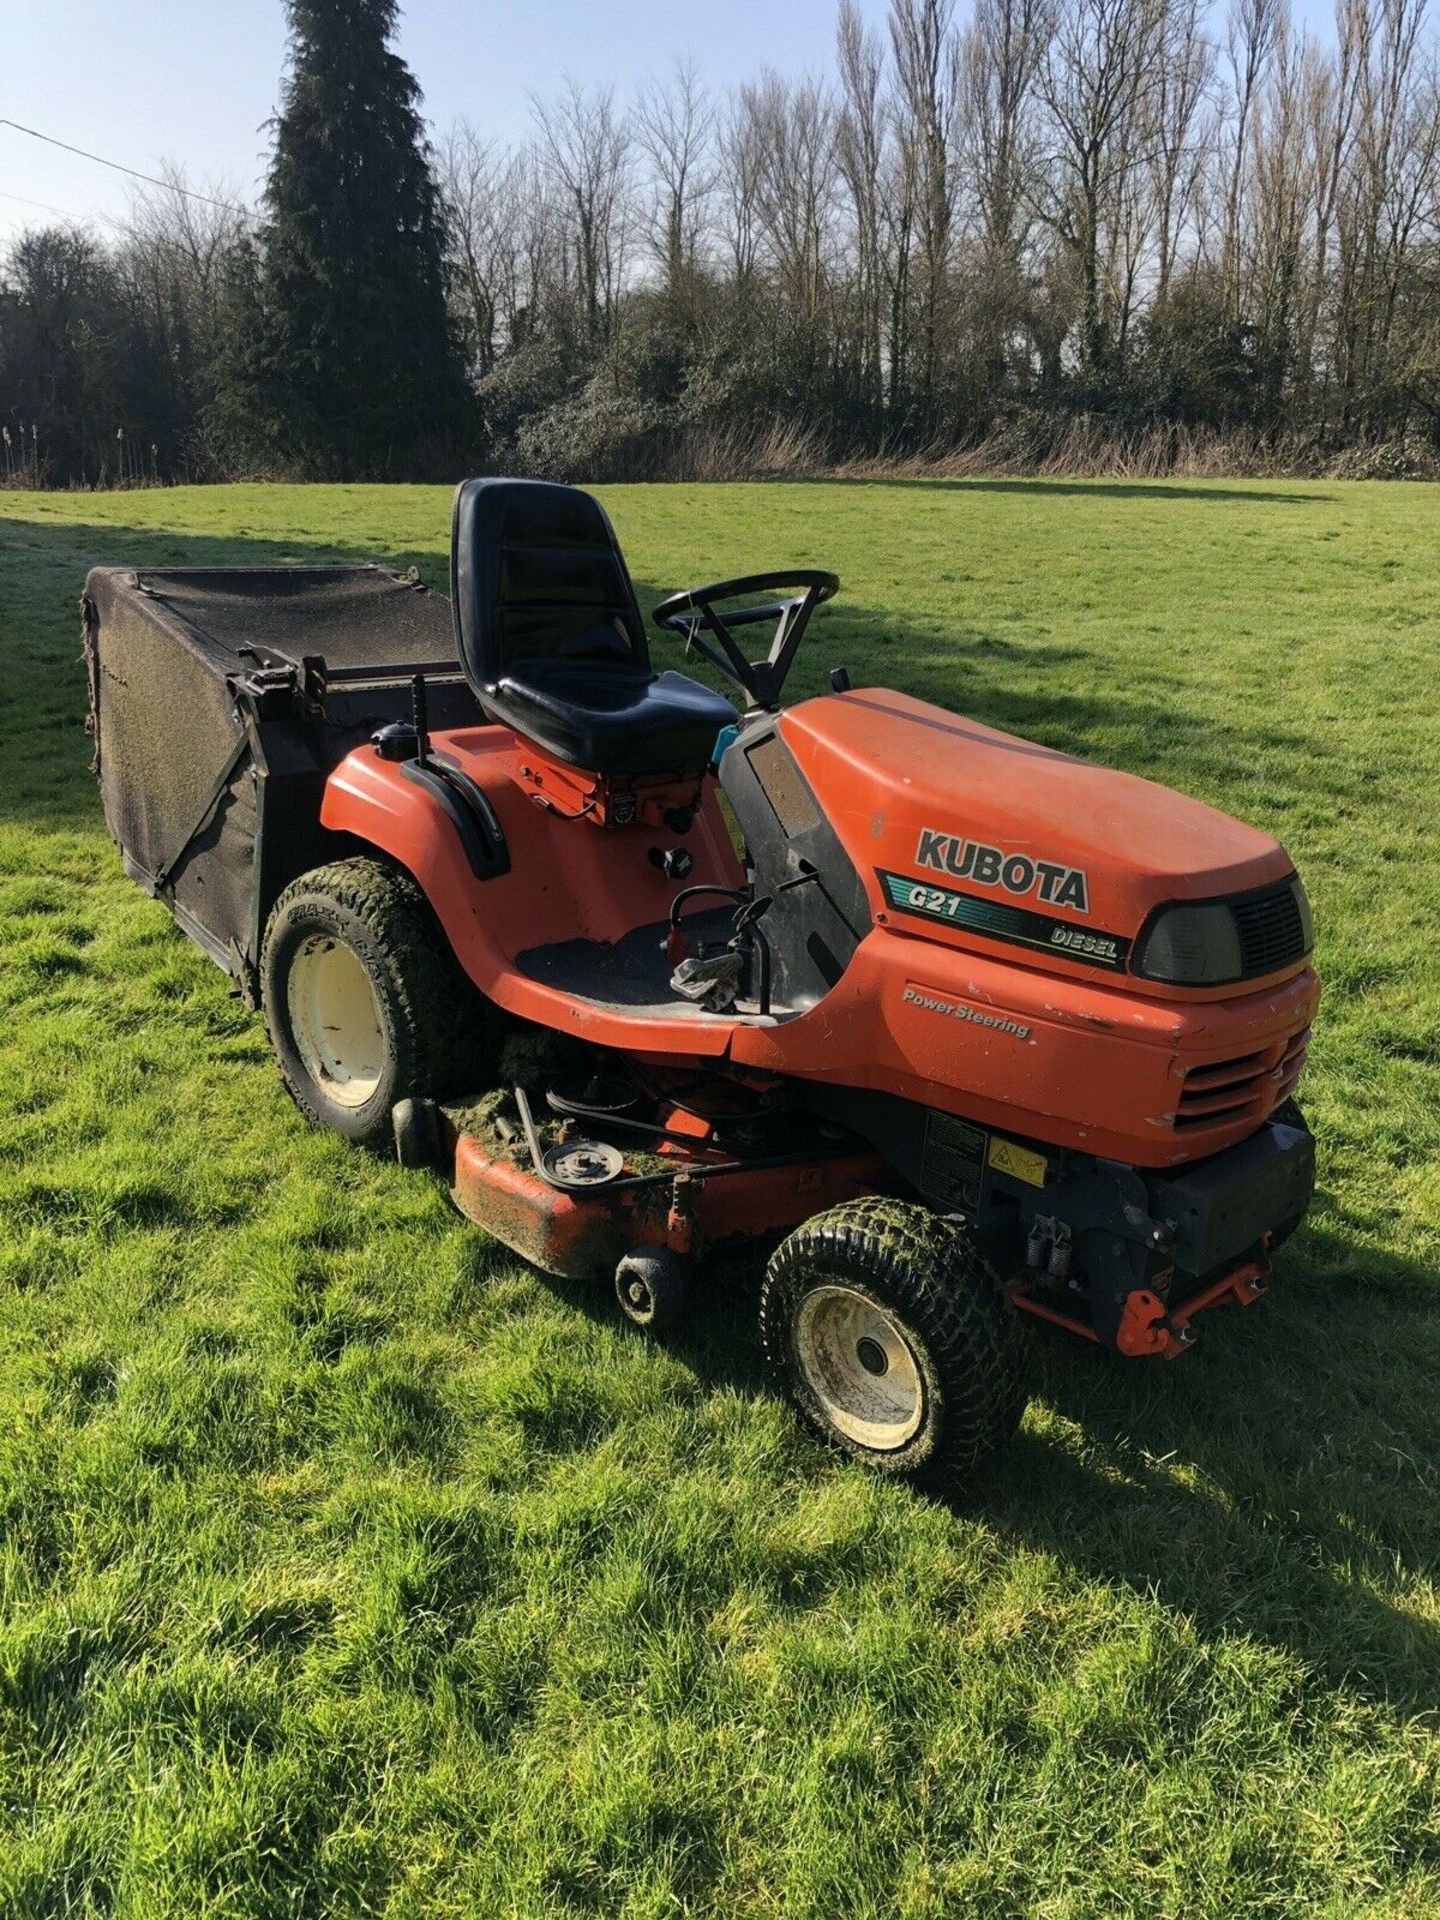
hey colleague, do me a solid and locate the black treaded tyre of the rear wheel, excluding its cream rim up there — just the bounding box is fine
[259,858,493,1152]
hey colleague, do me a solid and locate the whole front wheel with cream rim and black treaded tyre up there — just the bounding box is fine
[760,1198,1025,1486]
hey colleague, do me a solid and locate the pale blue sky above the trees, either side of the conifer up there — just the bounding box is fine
[0,0,1329,238]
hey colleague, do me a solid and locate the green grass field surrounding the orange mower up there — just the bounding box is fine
[0,482,1440,1920]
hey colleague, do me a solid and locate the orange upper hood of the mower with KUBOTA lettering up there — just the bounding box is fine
[780,689,1294,966]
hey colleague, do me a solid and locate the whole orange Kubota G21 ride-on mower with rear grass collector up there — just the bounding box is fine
[84,480,1319,1482]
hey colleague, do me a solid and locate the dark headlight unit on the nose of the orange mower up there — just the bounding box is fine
[1135,874,1315,987]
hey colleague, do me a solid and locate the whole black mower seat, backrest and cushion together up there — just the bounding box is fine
[449,480,735,774]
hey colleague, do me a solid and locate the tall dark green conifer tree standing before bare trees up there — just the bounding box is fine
[250,0,472,478]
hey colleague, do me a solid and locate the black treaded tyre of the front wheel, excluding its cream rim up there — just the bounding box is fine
[760,1198,1025,1490]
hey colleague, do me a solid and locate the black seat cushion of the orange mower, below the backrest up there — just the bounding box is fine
[482,659,735,774]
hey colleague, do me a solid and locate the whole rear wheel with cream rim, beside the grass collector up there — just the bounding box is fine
[261,858,490,1148]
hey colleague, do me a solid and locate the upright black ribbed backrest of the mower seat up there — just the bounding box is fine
[449,480,649,693]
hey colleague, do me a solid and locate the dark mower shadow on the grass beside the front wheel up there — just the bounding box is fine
[545,1227,1440,1722]
